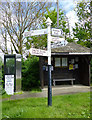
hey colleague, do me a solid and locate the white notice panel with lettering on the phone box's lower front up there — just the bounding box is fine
[5,75,14,95]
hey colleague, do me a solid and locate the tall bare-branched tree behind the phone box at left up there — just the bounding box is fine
[0,2,51,55]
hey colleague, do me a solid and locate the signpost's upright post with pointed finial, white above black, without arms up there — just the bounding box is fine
[46,18,52,106]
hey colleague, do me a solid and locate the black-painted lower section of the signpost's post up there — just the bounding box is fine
[48,65,52,106]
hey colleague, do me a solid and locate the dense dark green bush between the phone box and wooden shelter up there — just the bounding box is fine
[22,56,40,91]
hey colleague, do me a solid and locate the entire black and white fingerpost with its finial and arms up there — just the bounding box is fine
[24,17,65,106]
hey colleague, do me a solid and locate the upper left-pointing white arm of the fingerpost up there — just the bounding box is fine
[24,29,47,37]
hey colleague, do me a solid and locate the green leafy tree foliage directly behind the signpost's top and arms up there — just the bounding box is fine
[26,9,70,49]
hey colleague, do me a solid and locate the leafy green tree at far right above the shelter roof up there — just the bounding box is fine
[73,0,92,47]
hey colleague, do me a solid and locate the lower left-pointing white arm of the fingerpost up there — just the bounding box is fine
[30,48,48,56]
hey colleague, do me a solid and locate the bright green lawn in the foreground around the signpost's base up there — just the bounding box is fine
[2,92,90,118]
